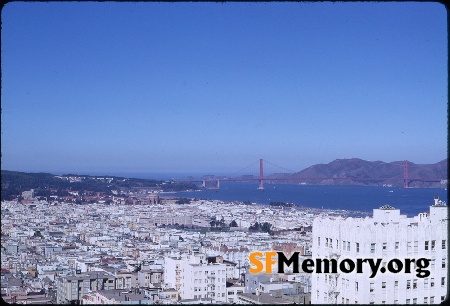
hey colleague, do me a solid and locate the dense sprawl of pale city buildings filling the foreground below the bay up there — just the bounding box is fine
[1,177,448,304]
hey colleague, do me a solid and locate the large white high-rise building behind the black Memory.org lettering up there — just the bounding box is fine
[311,197,448,304]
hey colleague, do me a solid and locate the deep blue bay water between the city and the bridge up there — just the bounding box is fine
[174,182,447,217]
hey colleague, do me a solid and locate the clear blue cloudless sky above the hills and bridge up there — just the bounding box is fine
[1,2,448,174]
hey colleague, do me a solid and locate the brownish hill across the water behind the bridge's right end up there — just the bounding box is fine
[268,158,448,187]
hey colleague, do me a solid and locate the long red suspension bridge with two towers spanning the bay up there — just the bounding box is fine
[178,158,442,189]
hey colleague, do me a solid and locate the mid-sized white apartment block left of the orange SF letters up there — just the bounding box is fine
[164,254,227,302]
